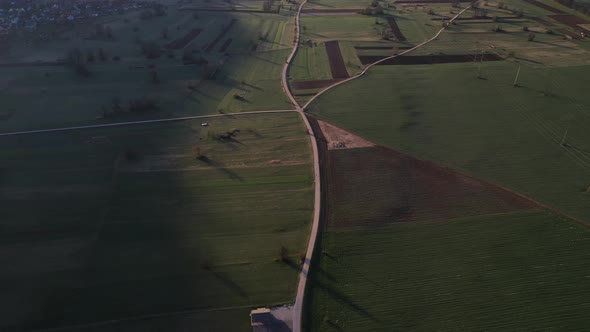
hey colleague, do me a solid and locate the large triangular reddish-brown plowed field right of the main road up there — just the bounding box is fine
[324,147,537,227]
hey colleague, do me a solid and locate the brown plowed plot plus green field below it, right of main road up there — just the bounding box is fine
[307,147,590,331]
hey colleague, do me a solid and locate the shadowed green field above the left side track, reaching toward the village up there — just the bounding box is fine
[0,6,292,131]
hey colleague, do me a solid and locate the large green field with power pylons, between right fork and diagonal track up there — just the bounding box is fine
[310,62,590,222]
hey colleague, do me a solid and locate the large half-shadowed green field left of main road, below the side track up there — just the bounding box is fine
[0,113,313,331]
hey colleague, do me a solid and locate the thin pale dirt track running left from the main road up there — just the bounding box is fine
[0,110,296,137]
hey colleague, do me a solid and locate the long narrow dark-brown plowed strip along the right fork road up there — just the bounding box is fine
[359,54,503,66]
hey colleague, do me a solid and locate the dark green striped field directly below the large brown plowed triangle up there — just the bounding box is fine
[308,212,590,331]
